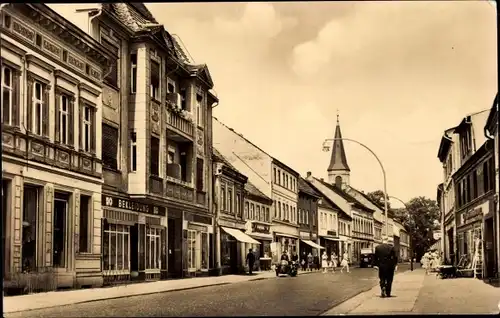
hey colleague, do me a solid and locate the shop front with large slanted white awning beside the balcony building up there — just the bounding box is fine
[219,219,260,275]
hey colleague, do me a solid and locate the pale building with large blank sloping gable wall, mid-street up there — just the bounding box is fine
[213,118,300,261]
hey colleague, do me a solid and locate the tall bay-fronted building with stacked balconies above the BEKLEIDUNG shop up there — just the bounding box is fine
[51,3,217,282]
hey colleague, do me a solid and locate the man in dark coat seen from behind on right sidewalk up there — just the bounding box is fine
[374,239,398,297]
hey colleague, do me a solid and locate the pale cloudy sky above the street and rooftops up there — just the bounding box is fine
[49,1,498,206]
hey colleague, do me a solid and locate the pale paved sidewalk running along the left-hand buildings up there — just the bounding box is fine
[3,271,315,313]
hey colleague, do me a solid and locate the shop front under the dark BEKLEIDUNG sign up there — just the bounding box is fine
[102,194,167,284]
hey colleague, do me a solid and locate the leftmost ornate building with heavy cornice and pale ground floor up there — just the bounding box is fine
[0,3,117,292]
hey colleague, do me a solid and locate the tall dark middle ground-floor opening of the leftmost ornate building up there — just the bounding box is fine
[52,192,69,268]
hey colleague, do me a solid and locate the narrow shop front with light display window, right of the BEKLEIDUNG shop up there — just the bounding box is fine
[182,211,214,277]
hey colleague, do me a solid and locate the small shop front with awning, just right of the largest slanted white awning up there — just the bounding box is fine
[245,220,273,270]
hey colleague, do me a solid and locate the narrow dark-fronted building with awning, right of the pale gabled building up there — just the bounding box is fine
[297,177,324,259]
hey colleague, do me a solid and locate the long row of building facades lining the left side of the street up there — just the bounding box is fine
[0,3,409,294]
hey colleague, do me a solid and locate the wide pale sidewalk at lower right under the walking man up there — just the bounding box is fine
[323,269,500,315]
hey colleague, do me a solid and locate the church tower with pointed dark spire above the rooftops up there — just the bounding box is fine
[328,114,351,189]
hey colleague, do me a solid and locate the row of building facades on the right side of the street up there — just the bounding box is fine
[437,97,500,278]
